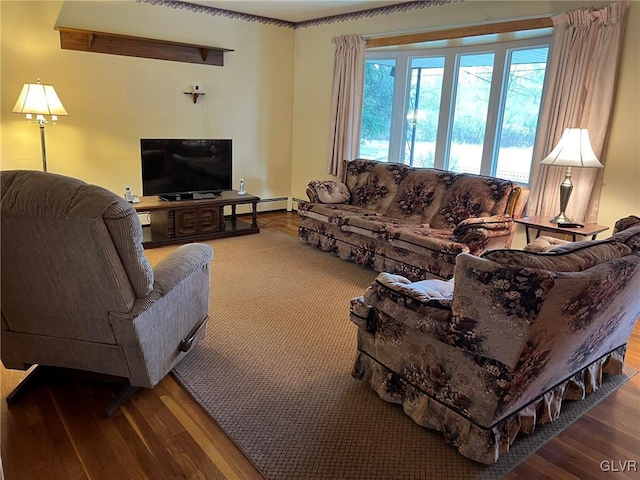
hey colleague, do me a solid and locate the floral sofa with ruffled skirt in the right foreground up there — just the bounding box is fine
[351,225,640,464]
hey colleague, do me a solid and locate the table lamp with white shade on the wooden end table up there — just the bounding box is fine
[540,128,604,223]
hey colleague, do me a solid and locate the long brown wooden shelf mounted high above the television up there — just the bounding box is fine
[57,27,233,66]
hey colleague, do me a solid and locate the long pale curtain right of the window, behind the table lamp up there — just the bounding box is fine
[527,1,630,223]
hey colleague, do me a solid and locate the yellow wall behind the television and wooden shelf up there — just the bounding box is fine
[0,1,294,198]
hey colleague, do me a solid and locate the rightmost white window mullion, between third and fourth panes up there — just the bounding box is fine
[480,46,507,175]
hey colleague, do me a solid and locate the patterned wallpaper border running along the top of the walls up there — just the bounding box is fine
[136,0,456,29]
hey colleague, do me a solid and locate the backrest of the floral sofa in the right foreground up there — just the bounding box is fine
[452,241,640,420]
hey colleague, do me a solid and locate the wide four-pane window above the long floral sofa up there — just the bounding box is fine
[360,37,549,184]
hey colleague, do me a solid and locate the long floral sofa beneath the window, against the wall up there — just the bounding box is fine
[298,159,529,280]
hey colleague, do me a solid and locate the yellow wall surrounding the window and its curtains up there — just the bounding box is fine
[292,1,640,247]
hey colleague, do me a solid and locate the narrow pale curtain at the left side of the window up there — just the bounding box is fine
[327,35,366,176]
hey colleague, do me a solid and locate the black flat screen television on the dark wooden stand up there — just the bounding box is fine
[140,138,233,200]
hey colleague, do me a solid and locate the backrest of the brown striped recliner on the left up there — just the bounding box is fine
[0,170,153,343]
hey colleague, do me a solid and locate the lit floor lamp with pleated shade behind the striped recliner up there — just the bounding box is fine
[13,78,69,172]
